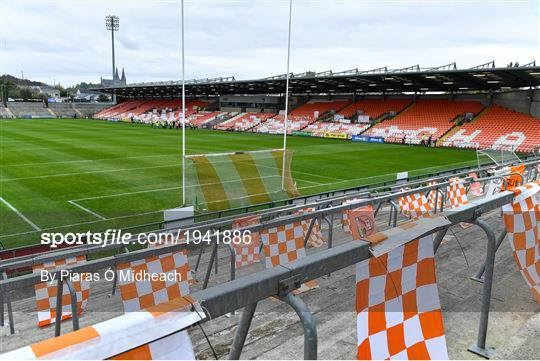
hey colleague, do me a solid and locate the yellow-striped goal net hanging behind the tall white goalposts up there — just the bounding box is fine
[184,149,299,212]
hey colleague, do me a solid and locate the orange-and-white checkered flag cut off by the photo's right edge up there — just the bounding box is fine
[502,181,540,303]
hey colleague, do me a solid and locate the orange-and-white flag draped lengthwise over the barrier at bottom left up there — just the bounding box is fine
[2,296,206,360]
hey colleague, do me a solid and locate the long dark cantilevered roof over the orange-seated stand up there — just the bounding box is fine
[95,62,540,97]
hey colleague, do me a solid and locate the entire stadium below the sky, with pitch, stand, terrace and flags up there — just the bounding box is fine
[0,1,540,360]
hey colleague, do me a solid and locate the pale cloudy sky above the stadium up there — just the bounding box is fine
[0,0,540,86]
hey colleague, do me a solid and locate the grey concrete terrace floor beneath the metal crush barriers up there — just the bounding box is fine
[0,204,540,359]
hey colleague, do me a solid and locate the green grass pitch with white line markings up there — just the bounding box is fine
[0,119,476,248]
